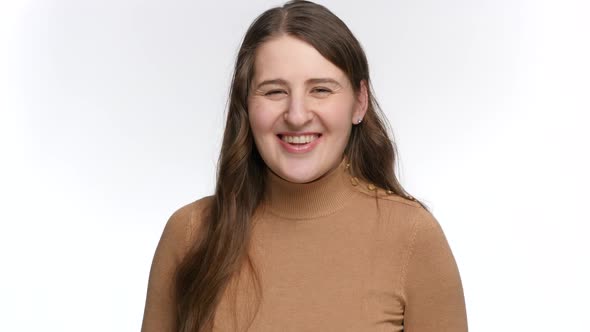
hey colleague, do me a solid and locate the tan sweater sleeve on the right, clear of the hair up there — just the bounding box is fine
[404,210,467,332]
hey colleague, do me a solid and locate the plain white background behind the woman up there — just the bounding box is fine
[0,0,590,332]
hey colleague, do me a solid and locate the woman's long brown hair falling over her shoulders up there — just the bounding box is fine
[175,1,427,332]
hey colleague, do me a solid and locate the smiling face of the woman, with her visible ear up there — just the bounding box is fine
[248,35,367,183]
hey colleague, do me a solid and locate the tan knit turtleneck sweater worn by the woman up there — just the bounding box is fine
[142,164,467,332]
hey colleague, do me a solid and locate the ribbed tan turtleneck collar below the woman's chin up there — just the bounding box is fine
[265,158,354,219]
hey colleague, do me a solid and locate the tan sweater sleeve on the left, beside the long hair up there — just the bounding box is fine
[141,207,190,332]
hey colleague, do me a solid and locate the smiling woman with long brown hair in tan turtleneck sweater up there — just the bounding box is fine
[142,1,467,332]
